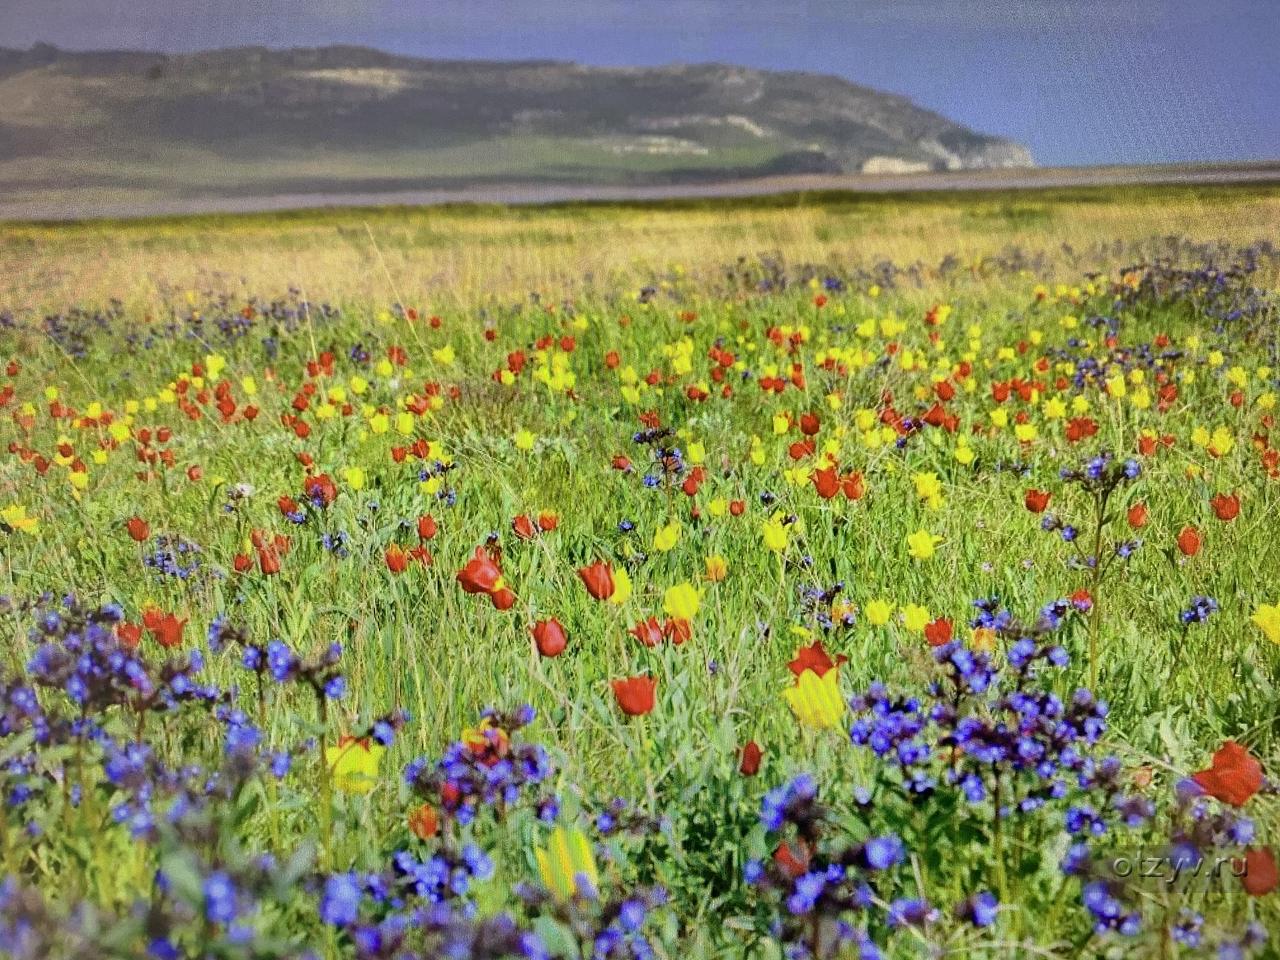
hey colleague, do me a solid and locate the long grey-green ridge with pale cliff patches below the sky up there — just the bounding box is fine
[0,44,1033,204]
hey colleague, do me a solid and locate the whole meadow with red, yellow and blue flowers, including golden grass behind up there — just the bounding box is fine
[0,187,1280,960]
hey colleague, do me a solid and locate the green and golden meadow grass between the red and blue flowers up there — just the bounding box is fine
[0,188,1280,957]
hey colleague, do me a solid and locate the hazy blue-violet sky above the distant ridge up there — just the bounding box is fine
[0,0,1280,165]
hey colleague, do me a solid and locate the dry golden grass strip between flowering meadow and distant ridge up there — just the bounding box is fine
[0,186,1280,311]
